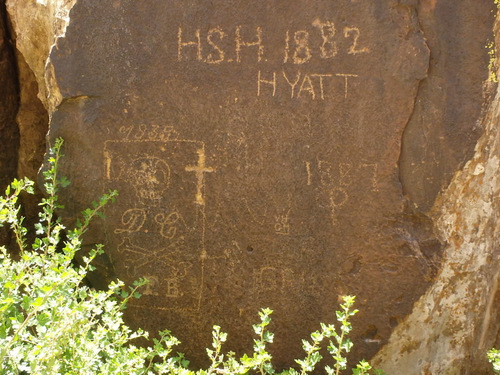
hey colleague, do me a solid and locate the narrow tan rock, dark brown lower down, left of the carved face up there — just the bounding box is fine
[2,0,76,232]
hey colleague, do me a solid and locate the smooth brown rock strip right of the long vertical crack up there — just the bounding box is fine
[399,0,494,212]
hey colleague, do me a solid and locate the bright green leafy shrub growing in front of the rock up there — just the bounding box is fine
[0,139,381,375]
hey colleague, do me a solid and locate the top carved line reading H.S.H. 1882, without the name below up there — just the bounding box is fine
[177,19,370,65]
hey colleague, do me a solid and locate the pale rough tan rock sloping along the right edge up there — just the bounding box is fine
[373,11,500,375]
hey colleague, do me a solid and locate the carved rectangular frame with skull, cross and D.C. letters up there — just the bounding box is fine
[103,133,215,310]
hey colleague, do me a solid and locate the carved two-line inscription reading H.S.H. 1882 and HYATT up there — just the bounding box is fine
[177,18,370,100]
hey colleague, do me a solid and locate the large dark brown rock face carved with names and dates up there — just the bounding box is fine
[4,0,492,372]
